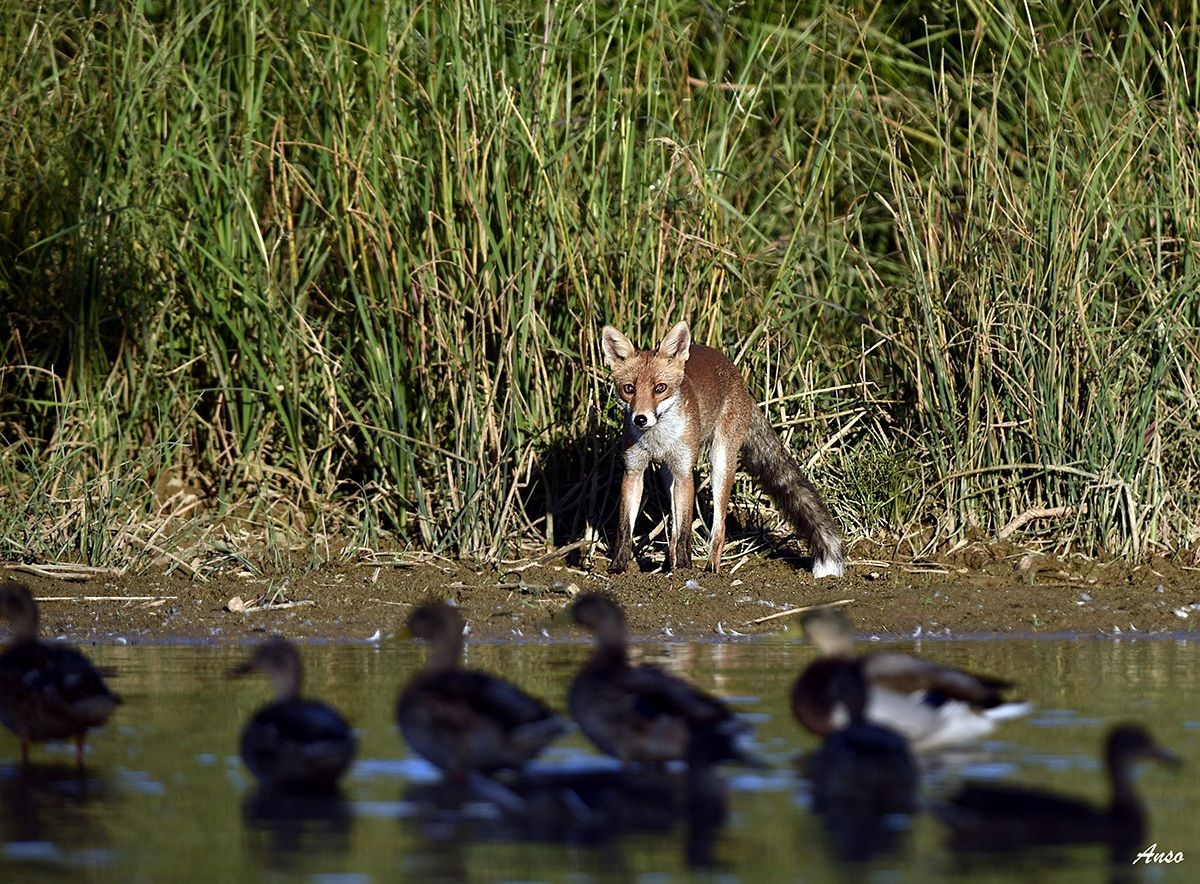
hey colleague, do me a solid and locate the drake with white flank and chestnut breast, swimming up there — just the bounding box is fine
[792,608,1033,752]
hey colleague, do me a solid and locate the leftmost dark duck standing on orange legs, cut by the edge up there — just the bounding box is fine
[0,581,121,768]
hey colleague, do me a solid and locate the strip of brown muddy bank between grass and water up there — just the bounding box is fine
[0,537,1200,643]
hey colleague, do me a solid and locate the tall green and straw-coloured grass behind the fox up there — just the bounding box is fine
[0,0,1200,571]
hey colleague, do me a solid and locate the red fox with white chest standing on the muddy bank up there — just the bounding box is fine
[601,323,845,577]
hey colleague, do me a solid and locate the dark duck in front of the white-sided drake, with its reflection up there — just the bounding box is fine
[805,662,919,861]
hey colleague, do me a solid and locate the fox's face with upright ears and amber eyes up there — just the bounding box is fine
[602,323,691,431]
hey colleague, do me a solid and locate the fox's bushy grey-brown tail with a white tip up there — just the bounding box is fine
[739,409,845,577]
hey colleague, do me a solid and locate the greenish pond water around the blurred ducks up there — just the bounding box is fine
[0,639,1200,882]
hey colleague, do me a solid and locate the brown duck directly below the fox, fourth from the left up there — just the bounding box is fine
[568,593,756,764]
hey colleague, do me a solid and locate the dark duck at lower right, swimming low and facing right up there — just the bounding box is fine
[934,722,1181,859]
